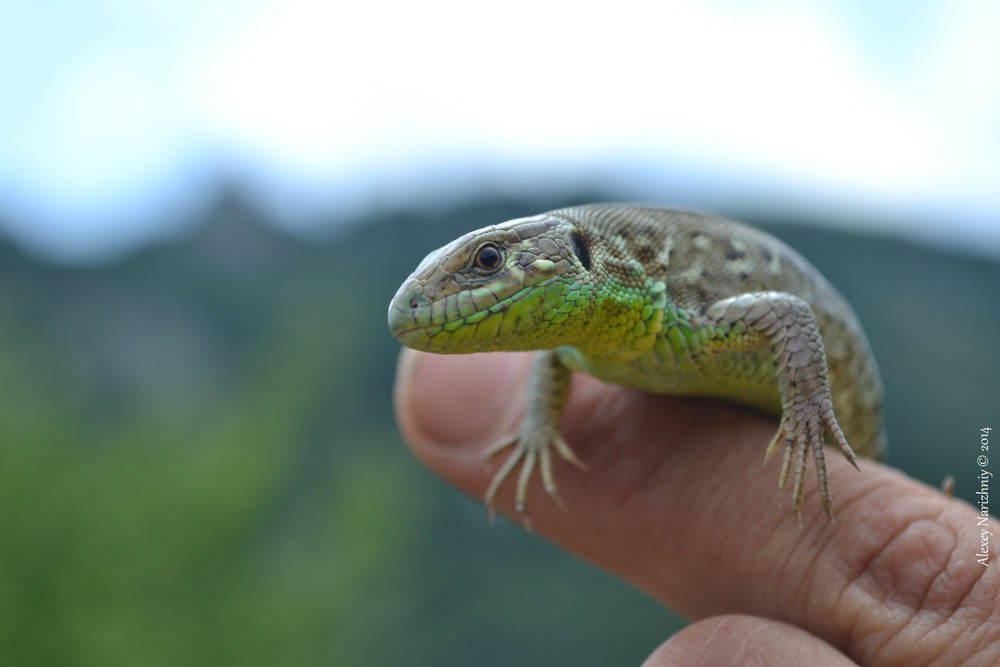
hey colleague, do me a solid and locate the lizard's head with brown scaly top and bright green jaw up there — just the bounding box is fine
[389,215,593,353]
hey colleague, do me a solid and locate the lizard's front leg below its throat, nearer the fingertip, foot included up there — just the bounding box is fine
[483,351,586,528]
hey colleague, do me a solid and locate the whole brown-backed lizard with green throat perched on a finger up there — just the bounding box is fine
[389,204,886,519]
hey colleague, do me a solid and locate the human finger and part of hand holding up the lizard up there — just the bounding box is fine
[395,350,1000,667]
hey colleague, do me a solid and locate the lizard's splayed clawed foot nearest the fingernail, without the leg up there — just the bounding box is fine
[483,425,587,530]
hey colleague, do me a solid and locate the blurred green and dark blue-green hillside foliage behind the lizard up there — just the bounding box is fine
[0,193,1000,667]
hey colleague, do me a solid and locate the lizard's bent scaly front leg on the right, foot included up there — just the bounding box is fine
[705,292,858,521]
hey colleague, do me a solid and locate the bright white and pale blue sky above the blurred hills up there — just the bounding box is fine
[0,0,1000,261]
